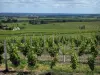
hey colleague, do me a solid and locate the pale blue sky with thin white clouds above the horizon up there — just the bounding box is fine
[0,0,100,14]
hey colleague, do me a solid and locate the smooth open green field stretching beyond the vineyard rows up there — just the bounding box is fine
[0,21,100,38]
